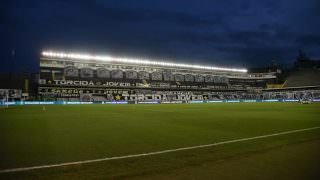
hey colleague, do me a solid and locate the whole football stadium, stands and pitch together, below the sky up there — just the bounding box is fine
[0,51,320,179]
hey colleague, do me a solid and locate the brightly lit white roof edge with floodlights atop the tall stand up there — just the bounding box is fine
[42,51,248,73]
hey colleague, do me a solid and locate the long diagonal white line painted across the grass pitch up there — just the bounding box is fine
[0,126,320,174]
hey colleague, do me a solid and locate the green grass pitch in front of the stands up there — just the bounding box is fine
[0,103,320,179]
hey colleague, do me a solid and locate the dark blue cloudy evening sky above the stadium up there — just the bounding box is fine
[0,0,320,72]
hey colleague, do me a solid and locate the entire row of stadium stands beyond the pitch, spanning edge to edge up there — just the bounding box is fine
[0,52,320,103]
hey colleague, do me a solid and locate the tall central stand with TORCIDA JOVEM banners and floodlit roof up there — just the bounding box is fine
[38,51,284,103]
